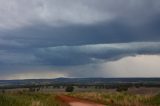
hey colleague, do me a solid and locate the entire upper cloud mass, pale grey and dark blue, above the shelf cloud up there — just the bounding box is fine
[0,0,160,49]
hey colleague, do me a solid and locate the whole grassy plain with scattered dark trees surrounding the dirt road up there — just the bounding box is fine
[0,84,160,106]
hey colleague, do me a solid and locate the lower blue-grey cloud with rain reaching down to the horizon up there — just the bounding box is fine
[0,42,160,78]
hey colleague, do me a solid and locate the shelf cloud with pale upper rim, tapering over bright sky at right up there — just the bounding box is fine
[35,42,160,66]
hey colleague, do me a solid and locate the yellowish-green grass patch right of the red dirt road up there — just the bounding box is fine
[68,92,160,106]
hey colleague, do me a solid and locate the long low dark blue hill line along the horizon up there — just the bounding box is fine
[0,78,160,87]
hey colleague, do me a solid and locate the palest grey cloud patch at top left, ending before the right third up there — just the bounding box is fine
[0,0,109,29]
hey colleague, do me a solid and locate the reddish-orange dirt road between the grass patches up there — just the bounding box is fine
[57,95,105,106]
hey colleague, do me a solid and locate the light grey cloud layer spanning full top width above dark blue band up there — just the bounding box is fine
[0,0,160,29]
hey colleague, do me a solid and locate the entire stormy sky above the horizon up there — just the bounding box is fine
[0,0,160,80]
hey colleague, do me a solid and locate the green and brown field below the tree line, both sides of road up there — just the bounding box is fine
[0,88,160,106]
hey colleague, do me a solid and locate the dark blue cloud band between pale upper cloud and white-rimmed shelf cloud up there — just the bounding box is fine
[2,19,160,48]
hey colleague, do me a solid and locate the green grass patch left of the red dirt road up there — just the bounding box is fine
[0,92,59,106]
